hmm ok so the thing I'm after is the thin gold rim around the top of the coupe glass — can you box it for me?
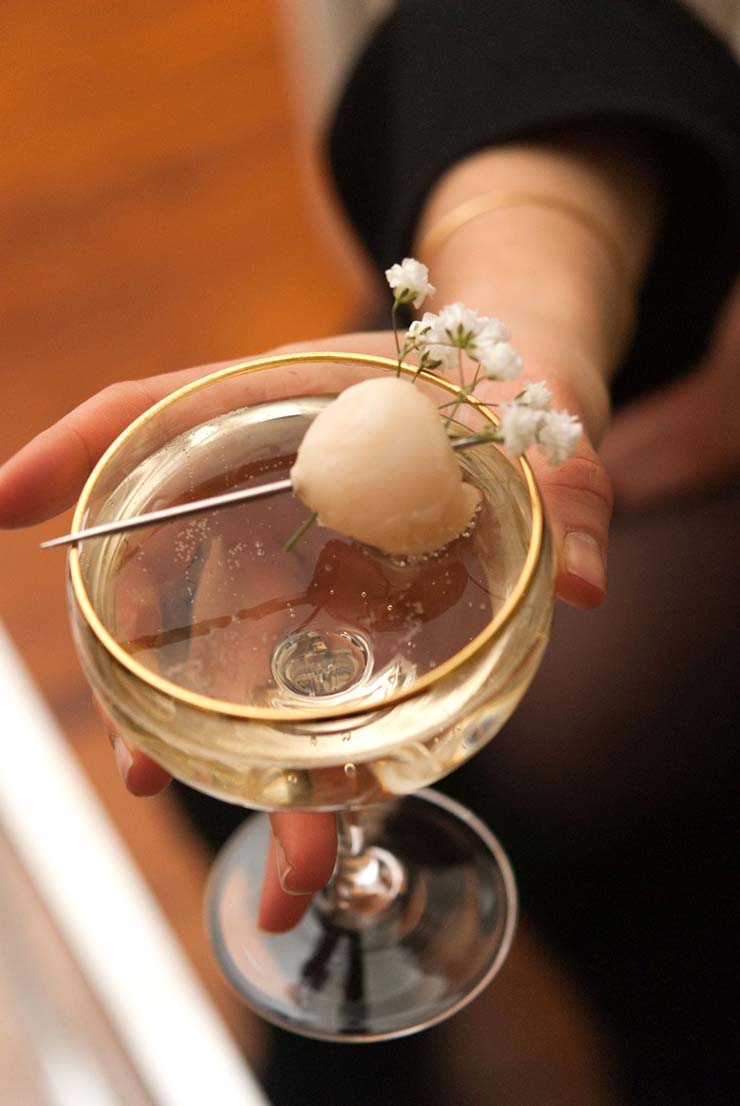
[69,352,544,722]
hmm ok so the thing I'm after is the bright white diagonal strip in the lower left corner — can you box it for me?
[0,625,268,1106]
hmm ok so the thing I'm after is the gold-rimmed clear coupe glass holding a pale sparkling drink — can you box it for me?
[69,353,553,1041]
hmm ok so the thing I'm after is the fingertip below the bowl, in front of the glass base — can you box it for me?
[258,813,336,933]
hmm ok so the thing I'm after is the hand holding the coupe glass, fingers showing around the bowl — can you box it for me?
[0,334,611,932]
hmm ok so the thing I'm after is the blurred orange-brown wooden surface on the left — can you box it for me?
[0,0,357,1057]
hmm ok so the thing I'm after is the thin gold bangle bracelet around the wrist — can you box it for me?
[417,192,633,288]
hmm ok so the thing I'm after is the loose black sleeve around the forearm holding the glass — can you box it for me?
[330,0,740,398]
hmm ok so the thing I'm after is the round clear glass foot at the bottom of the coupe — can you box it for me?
[207,791,517,1042]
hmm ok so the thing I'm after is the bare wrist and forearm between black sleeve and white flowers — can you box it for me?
[416,131,659,437]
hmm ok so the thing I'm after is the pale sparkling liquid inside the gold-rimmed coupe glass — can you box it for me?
[85,397,537,805]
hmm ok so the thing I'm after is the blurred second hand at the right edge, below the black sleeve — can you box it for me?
[602,280,740,510]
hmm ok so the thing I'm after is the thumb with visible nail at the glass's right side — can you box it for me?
[531,437,613,607]
